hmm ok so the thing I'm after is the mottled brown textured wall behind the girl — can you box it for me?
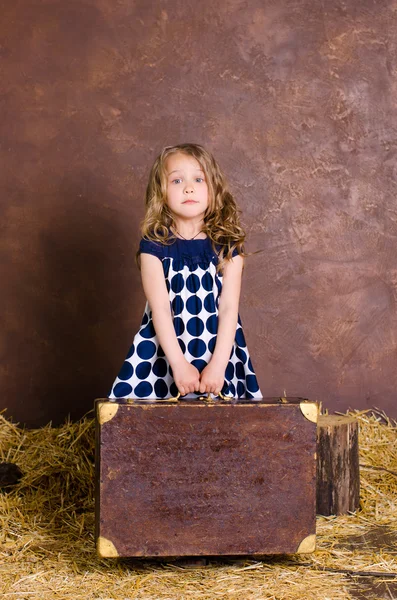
[0,0,397,426]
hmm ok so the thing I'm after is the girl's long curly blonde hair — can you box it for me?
[137,144,247,269]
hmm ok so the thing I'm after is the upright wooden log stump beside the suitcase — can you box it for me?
[317,415,360,515]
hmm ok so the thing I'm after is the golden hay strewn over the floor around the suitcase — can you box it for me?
[0,411,397,600]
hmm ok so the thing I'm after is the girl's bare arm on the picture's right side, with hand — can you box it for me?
[200,255,244,395]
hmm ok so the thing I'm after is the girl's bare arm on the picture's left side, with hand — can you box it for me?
[141,253,200,396]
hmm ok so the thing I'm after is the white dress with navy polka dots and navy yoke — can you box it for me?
[108,238,262,400]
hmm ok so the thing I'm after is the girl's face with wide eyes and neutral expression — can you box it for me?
[165,153,209,221]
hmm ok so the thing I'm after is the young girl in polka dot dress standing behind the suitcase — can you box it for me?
[109,144,262,400]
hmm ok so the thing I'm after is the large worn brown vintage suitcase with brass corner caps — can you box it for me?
[96,399,318,557]
